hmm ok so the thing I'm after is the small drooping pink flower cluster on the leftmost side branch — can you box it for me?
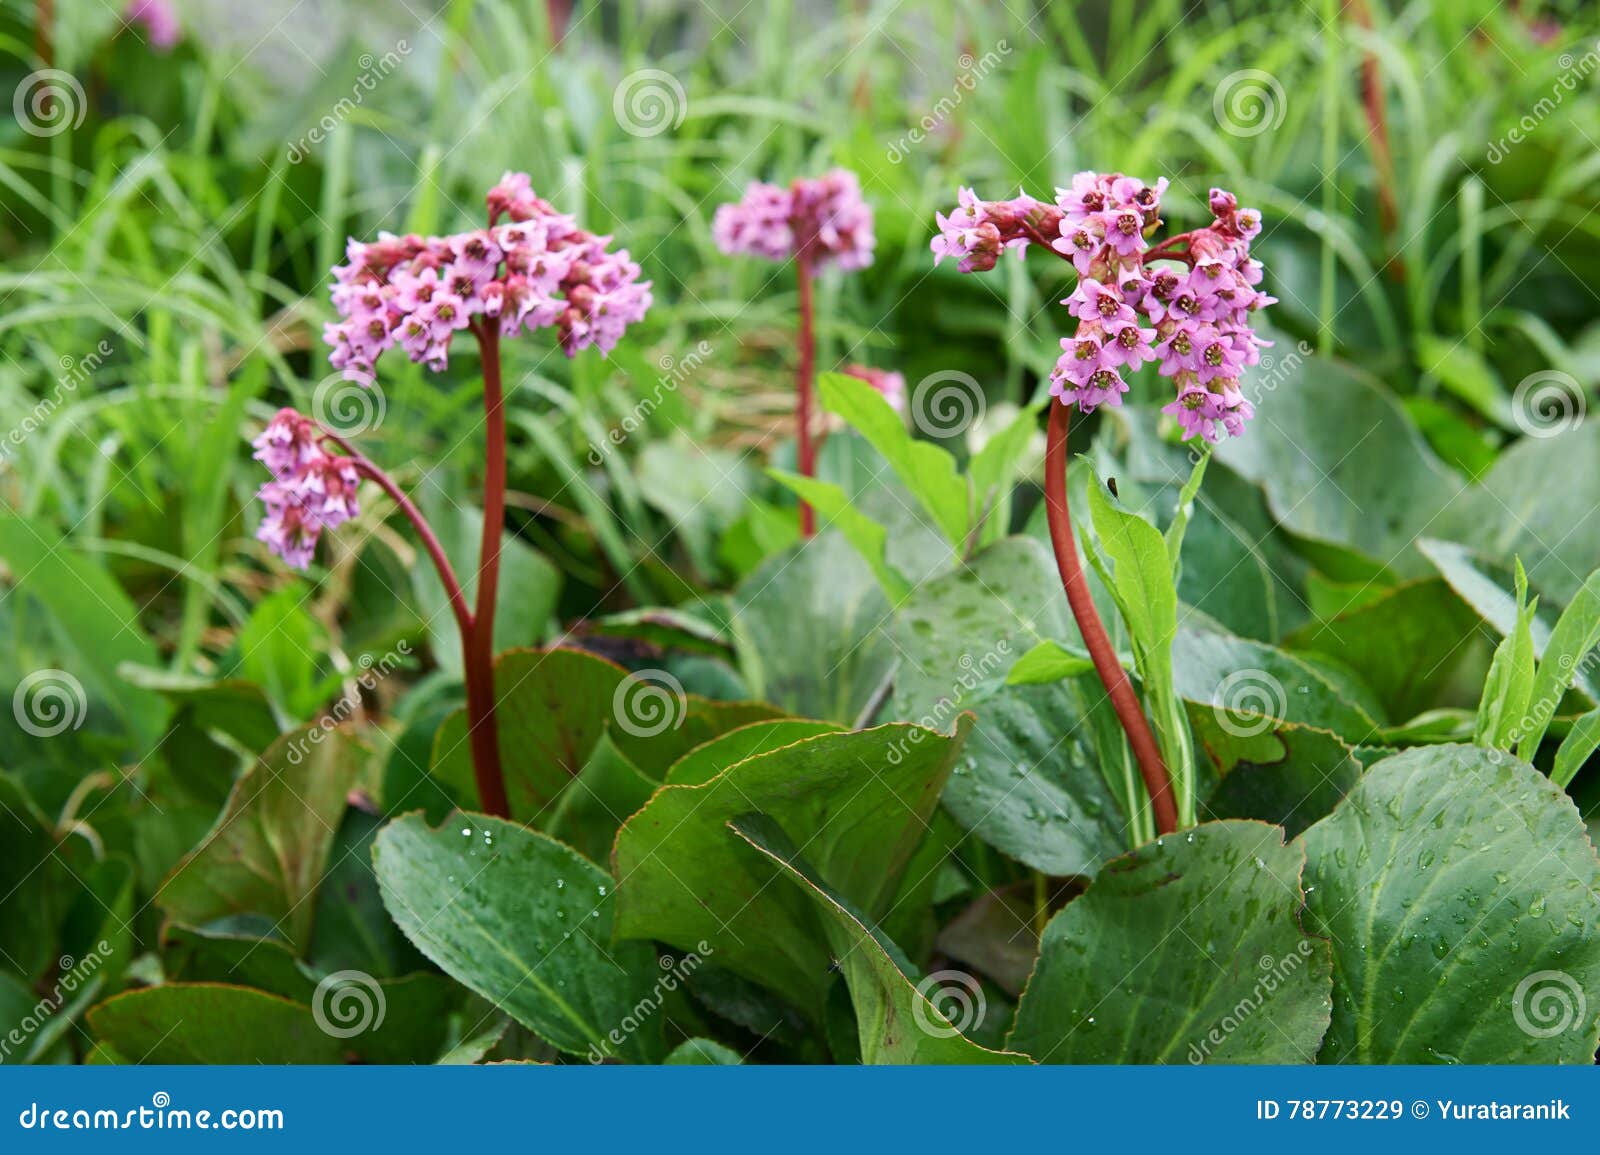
[253,410,362,570]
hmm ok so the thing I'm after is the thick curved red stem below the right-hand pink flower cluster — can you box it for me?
[1045,400,1178,833]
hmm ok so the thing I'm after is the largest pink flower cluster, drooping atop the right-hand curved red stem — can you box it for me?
[933,173,1274,442]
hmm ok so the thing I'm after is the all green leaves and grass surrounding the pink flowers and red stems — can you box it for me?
[0,0,1600,1064]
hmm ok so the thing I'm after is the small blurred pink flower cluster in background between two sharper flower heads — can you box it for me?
[710,168,877,269]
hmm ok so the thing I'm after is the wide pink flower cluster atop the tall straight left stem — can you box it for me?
[323,173,651,386]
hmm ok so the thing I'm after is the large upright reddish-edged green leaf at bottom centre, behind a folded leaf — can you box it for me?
[613,720,970,1021]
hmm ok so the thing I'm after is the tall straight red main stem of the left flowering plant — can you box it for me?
[462,323,510,817]
